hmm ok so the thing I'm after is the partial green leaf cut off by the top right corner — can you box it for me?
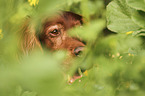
[126,0,145,11]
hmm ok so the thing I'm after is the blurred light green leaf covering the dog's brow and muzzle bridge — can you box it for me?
[69,20,105,41]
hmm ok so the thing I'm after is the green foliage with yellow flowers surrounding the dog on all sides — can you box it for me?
[0,0,145,96]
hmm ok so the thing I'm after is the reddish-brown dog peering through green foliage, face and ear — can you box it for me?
[22,12,85,56]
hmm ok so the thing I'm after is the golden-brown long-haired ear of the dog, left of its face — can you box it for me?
[20,17,42,54]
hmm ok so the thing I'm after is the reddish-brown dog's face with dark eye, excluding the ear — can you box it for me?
[39,12,85,56]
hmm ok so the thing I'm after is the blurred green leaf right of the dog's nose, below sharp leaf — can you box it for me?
[94,34,141,56]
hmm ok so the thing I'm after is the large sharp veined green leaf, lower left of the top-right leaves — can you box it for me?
[107,0,140,33]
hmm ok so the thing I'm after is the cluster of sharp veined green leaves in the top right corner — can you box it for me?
[107,0,145,35]
